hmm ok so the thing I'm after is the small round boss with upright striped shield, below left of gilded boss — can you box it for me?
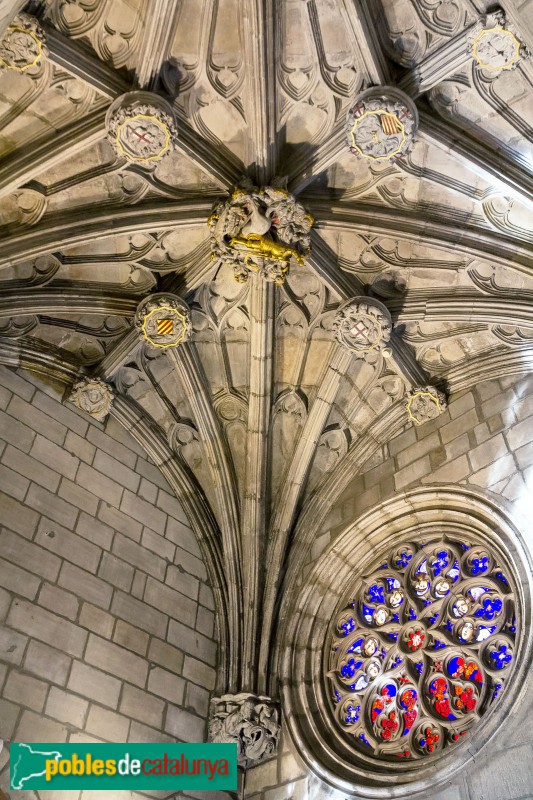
[135,292,192,347]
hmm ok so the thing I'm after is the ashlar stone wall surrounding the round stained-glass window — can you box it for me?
[245,377,533,800]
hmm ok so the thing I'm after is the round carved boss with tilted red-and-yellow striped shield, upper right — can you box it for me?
[347,86,418,161]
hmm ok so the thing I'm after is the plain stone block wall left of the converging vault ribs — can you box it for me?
[0,367,217,756]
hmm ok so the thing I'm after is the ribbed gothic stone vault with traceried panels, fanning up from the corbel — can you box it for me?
[0,0,533,716]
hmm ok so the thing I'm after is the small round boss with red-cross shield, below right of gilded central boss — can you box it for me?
[333,297,392,358]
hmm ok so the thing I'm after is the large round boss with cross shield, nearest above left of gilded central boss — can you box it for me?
[106,92,178,166]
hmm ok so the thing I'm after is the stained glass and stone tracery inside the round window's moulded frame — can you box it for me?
[327,536,517,761]
